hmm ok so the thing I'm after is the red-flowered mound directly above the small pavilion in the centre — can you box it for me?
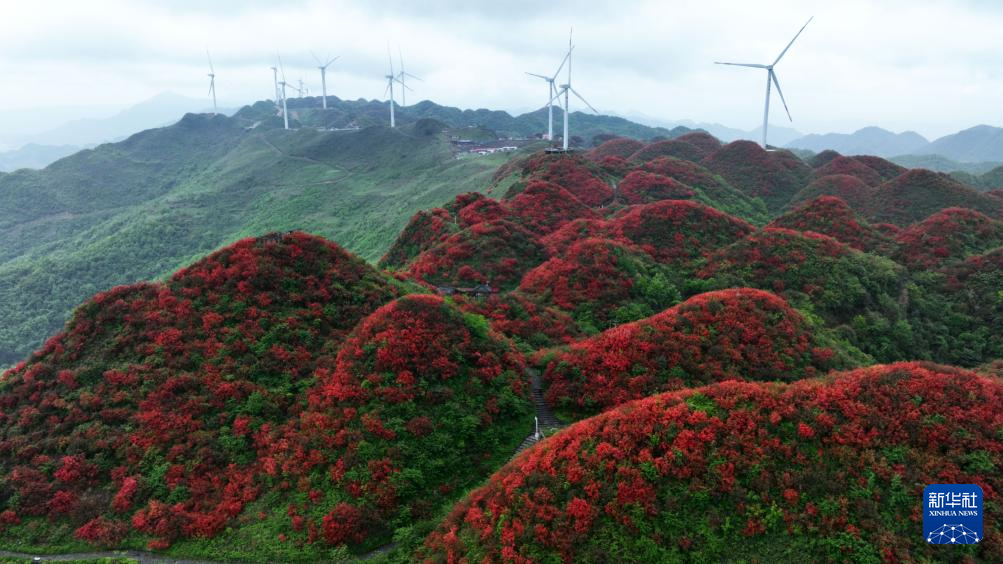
[407,220,545,289]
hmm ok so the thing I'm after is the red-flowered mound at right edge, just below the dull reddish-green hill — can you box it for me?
[896,208,1003,270]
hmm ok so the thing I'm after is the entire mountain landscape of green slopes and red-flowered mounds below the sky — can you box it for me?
[0,130,1003,563]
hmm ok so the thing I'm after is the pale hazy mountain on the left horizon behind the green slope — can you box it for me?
[28,91,227,146]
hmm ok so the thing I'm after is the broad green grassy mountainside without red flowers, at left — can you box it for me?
[0,116,521,366]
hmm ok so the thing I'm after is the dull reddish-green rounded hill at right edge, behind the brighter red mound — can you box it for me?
[862,169,1003,227]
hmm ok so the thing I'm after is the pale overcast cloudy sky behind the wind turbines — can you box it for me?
[0,0,1003,136]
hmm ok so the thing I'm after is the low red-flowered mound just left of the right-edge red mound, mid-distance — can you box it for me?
[767,196,893,252]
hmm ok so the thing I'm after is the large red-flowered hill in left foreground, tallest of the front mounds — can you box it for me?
[0,233,397,546]
